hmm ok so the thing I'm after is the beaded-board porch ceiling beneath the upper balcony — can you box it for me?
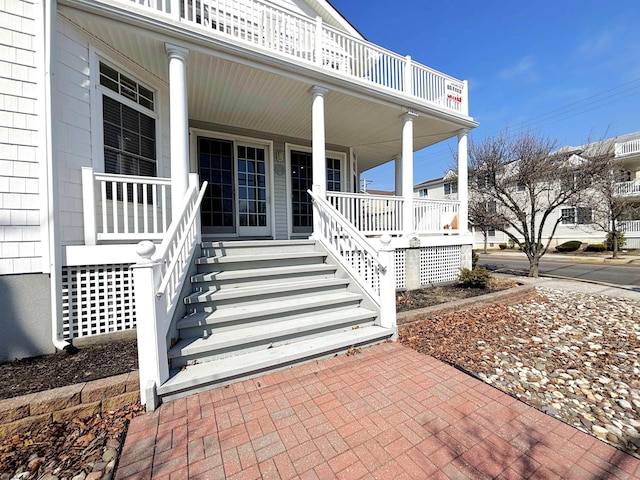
[59,6,464,170]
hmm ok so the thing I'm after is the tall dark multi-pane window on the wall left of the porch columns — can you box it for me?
[100,62,157,182]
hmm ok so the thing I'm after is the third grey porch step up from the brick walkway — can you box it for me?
[177,292,363,338]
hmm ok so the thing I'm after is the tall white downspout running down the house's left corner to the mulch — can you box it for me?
[41,0,71,350]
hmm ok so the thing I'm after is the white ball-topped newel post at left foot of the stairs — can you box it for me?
[131,240,169,411]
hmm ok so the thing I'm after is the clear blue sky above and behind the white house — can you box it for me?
[330,0,640,190]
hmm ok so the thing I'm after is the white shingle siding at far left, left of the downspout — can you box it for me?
[0,0,42,274]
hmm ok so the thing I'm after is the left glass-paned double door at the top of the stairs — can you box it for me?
[198,137,271,236]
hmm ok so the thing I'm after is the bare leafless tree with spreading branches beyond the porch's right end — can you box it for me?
[469,130,602,277]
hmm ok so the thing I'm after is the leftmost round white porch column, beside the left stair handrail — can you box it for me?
[165,43,189,218]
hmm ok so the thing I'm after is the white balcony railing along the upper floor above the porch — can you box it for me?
[120,0,469,115]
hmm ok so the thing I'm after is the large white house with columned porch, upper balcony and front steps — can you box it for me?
[0,0,477,403]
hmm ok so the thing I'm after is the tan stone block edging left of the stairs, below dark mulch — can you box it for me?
[0,371,140,440]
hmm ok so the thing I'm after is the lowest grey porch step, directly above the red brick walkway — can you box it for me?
[158,326,394,400]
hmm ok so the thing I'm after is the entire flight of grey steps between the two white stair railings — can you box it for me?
[158,240,388,400]
